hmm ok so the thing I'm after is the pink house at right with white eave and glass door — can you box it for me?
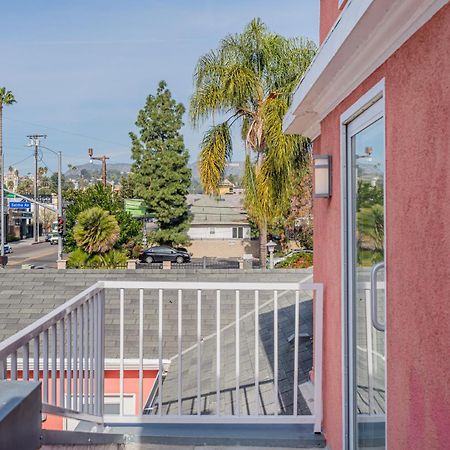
[284,0,450,450]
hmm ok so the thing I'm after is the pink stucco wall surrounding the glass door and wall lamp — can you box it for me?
[314,5,450,450]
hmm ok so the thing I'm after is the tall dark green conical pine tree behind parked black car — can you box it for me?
[130,81,191,245]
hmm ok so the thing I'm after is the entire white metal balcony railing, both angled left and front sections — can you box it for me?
[0,281,323,432]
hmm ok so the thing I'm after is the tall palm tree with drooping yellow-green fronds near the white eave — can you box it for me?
[190,19,316,267]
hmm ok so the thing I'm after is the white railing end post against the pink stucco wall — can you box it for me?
[313,284,323,433]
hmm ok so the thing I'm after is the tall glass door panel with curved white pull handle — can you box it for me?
[347,108,386,449]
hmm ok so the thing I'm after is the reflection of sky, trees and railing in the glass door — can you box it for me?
[351,119,386,449]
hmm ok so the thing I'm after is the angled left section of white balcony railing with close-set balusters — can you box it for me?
[0,283,104,422]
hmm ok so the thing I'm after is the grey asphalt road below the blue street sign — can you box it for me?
[7,238,58,269]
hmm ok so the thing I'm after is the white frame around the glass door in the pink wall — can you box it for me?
[340,78,387,450]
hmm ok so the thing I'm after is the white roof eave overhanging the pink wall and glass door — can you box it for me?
[283,0,448,139]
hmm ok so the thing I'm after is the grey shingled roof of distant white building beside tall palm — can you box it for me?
[187,194,248,225]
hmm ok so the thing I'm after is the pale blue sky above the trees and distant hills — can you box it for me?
[0,0,319,173]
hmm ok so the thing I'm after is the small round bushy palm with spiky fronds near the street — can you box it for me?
[73,206,120,254]
